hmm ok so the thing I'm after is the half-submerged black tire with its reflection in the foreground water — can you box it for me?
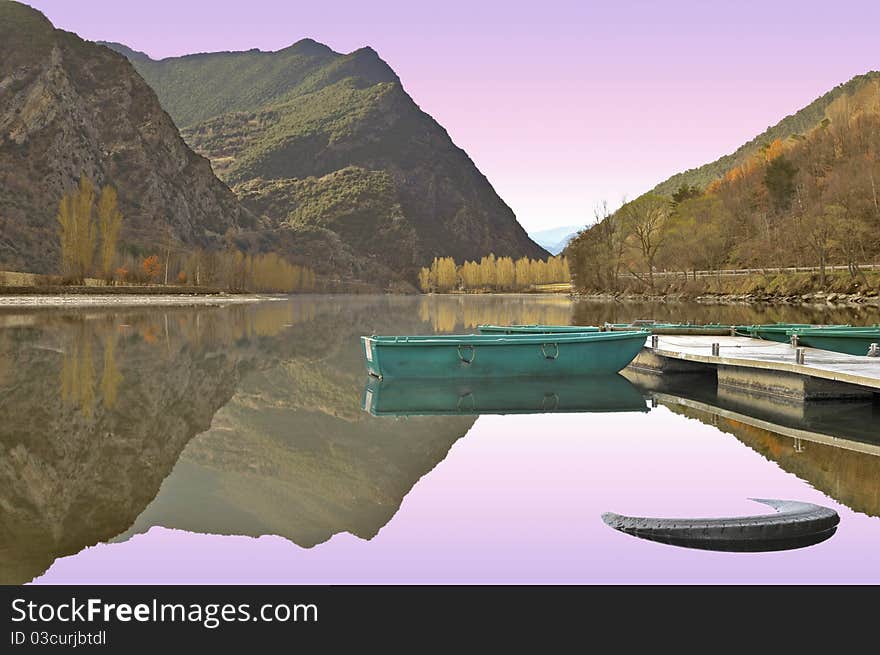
[602,498,840,552]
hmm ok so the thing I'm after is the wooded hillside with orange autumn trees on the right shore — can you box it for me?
[566,73,880,290]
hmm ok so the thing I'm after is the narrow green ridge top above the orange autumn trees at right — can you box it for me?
[651,71,880,196]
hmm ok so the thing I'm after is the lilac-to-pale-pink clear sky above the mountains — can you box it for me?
[29,0,880,231]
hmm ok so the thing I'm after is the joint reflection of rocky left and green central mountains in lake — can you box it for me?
[0,298,482,583]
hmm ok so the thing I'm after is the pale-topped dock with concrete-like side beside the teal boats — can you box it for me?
[630,335,880,402]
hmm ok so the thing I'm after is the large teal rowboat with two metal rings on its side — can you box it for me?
[361,331,648,378]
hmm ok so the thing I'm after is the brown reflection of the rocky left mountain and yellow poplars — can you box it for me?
[0,313,262,582]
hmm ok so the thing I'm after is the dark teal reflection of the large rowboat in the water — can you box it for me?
[363,374,648,416]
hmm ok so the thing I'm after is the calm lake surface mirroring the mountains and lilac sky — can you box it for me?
[0,296,880,584]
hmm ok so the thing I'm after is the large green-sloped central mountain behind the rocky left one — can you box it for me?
[107,39,547,280]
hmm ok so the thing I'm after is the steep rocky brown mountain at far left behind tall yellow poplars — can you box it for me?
[0,0,253,273]
